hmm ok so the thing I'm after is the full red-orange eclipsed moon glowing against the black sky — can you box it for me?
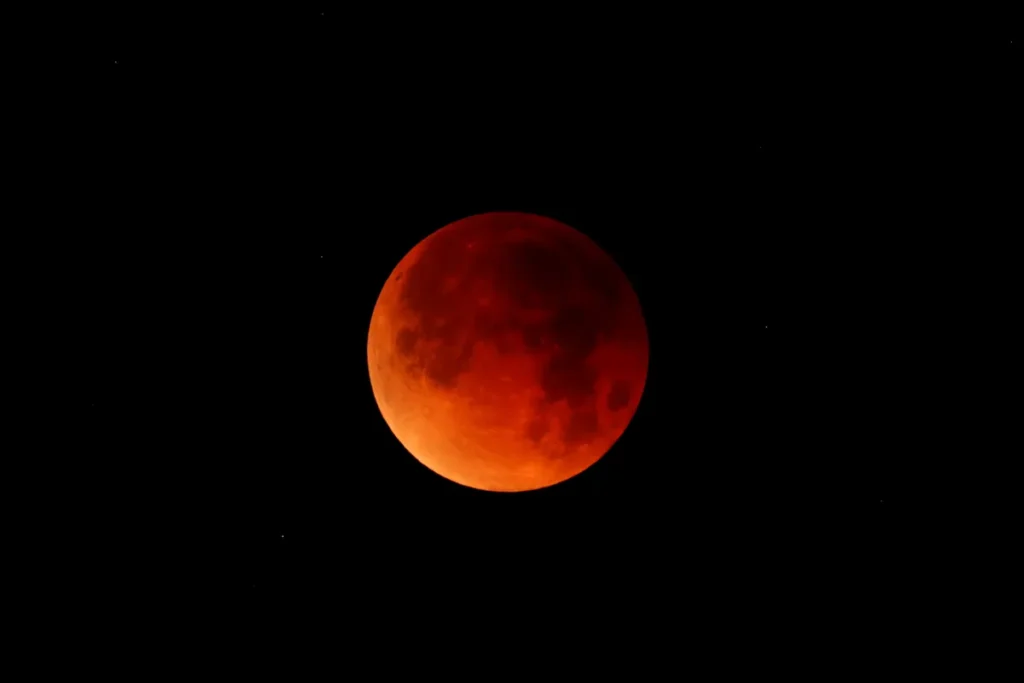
[367,213,648,492]
